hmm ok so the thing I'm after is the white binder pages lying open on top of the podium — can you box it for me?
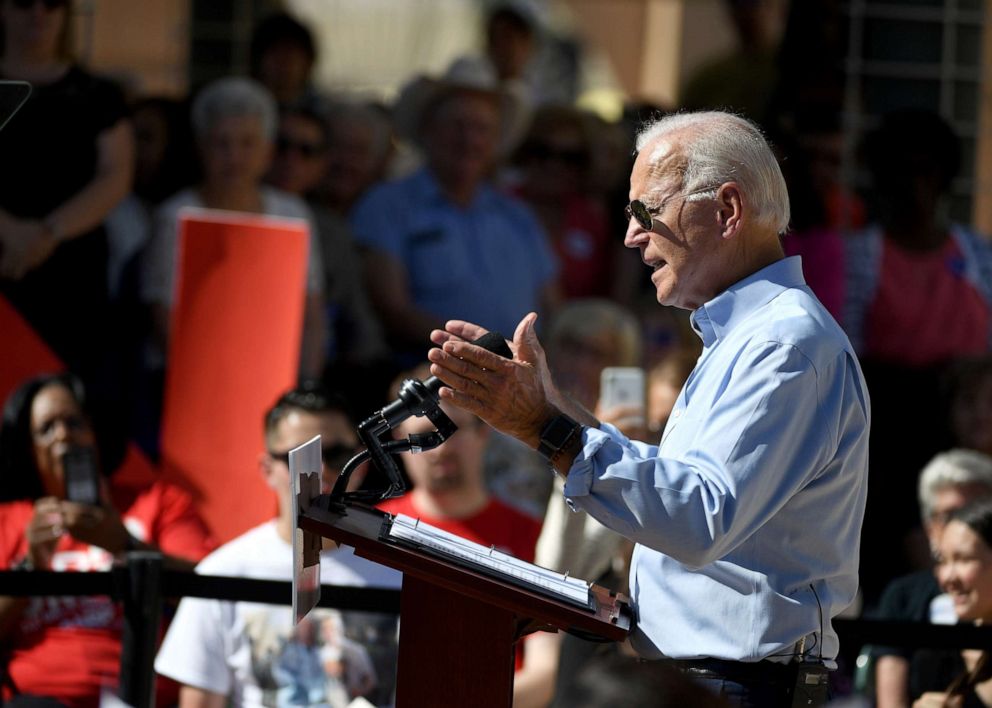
[385,514,595,610]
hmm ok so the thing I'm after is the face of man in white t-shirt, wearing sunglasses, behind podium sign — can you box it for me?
[262,409,363,502]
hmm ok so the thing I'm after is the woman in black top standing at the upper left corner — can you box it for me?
[0,0,133,388]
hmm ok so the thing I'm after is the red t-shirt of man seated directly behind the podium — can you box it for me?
[379,493,541,670]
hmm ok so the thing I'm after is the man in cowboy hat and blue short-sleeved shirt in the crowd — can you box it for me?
[351,58,559,361]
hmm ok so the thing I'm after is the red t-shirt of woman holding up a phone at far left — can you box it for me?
[0,481,216,708]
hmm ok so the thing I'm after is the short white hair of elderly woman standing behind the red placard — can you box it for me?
[191,76,279,141]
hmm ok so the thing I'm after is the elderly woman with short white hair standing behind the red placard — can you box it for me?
[141,78,325,378]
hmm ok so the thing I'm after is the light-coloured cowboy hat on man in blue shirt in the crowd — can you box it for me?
[393,57,530,155]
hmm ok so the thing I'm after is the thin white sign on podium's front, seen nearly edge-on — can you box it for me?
[289,435,323,622]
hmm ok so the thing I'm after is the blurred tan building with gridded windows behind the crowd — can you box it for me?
[76,0,992,233]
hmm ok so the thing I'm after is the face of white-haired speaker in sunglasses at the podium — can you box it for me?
[624,138,727,310]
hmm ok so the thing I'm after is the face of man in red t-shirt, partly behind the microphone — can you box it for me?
[397,405,489,497]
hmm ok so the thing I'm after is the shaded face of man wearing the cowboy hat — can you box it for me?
[424,91,499,191]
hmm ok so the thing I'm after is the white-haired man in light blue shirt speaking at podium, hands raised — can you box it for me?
[429,112,870,707]
